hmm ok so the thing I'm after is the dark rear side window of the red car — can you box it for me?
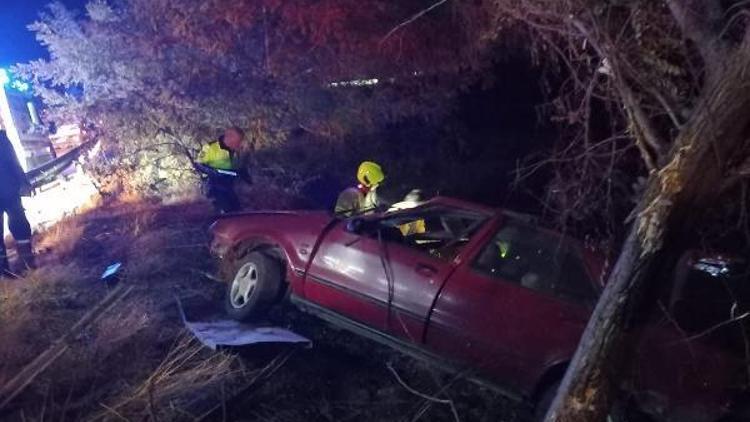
[473,222,596,303]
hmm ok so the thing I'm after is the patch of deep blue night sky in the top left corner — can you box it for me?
[0,0,87,67]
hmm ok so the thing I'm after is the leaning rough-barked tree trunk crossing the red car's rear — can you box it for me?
[546,50,750,422]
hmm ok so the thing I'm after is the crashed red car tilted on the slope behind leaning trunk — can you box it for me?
[211,198,745,421]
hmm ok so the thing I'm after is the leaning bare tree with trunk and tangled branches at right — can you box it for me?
[484,0,750,422]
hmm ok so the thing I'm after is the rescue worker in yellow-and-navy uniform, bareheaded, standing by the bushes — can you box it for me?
[196,127,252,213]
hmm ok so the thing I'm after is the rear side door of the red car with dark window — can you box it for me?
[426,220,596,392]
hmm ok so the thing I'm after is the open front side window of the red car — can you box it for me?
[379,207,486,259]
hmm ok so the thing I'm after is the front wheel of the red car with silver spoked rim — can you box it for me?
[224,252,283,321]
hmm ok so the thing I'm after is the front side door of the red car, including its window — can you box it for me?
[305,206,485,343]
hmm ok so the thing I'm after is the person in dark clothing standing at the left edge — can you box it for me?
[0,130,36,277]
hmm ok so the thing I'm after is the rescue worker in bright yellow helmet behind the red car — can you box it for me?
[335,161,385,217]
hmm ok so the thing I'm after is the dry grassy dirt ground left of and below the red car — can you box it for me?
[0,194,528,422]
